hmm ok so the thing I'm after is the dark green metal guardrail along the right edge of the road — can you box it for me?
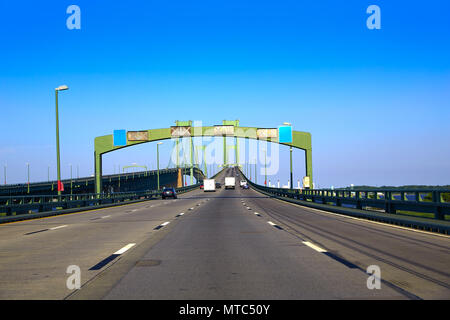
[241,172,450,234]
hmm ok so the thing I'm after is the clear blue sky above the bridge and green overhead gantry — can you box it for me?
[0,0,450,187]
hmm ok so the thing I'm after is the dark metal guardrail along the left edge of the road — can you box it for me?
[0,184,199,216]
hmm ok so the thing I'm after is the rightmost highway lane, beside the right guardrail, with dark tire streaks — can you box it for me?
[241,185,450,299]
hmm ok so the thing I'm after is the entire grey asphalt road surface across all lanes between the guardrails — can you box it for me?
[0,169,450,299]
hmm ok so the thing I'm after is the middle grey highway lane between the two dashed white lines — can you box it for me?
[86,169,411,299]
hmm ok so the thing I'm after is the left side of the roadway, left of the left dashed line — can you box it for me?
[0,186,210,299]
